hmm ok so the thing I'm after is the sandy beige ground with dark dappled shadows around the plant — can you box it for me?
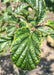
[0,0,54,75]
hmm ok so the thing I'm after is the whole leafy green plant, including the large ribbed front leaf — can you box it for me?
[0,0,54,70]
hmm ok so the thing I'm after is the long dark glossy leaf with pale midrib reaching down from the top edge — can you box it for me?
[26,0,46,23]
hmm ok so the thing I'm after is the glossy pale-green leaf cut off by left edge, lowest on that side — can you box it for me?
[0,35,11,53]
